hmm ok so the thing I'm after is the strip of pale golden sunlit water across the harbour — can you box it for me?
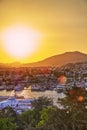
[0,87,64,103]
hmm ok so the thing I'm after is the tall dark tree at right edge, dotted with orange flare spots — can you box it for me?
[58,87,87,130]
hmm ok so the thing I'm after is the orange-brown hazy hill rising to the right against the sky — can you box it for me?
[24,51,87,67]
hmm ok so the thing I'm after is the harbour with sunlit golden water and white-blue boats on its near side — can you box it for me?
[0,87,65,112]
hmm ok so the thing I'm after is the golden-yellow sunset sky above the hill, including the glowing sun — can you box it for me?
[0,0,87,63]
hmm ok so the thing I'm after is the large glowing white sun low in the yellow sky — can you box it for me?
[2,26,40,60]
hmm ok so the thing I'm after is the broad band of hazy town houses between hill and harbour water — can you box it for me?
[0,62,87,91]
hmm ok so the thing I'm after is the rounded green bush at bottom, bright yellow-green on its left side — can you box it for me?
[37,107,70,130]
